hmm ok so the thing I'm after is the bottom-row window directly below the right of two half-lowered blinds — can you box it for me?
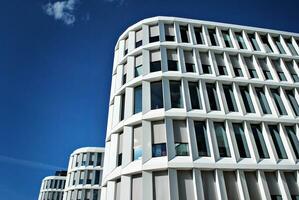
[177,170,196,200]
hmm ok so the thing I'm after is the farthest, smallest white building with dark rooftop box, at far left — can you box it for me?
[38,171,66,200]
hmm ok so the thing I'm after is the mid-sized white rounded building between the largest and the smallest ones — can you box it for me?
[63,147,104,200]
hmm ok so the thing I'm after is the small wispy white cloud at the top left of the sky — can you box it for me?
[43,0,79,25]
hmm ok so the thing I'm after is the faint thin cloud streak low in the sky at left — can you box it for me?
[0,155,63,170]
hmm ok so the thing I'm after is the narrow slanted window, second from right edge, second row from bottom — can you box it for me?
[269,125,288,159]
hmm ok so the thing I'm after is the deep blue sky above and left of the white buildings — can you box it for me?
[0,0,299,200]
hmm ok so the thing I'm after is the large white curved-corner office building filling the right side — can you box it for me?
[101,17,299,200]
